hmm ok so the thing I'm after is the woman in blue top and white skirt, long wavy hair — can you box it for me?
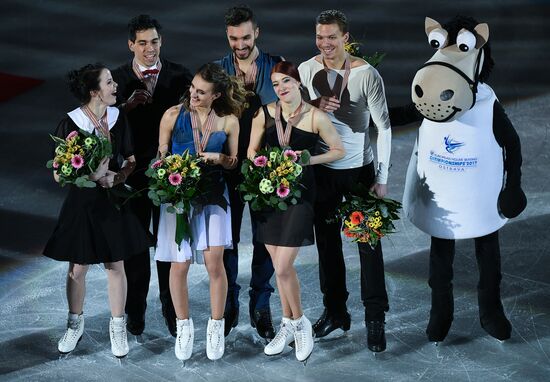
[155,64,246,360]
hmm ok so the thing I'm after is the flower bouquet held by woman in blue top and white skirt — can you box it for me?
[145,150,204,247]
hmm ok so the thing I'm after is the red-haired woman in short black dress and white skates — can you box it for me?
[247,61,344,361]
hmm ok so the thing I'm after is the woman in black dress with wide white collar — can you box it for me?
[44,64,152,357]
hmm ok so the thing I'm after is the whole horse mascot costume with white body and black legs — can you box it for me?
[403,16,527,343]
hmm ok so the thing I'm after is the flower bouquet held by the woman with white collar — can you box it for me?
[46,130,112,188]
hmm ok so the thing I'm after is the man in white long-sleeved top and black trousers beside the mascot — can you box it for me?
[298,10,391,352]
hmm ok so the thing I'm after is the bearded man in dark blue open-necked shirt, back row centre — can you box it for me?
[218,6,283,339]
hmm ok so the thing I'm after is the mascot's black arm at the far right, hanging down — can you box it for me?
[493,101,527,218]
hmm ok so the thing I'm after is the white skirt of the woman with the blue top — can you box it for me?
[155,188,233,264]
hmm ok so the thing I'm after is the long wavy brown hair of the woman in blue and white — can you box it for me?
[183,63,250,118]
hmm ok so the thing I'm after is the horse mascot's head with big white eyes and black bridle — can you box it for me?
[411,16,494,122]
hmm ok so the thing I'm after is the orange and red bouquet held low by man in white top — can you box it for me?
[336,188,401,248]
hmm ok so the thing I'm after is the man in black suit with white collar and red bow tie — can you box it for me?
[113,15,191,337]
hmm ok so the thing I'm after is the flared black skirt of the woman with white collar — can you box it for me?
[44,185,154,265]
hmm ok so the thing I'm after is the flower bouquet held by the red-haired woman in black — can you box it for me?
[239,147,310,211]
